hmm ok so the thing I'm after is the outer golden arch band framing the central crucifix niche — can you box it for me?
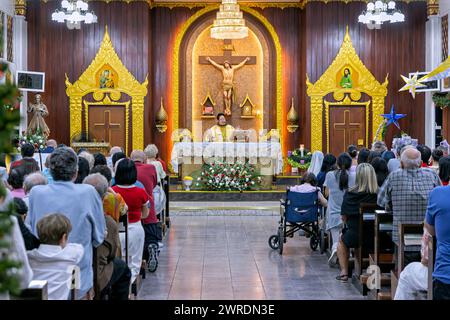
[172,5,283,150]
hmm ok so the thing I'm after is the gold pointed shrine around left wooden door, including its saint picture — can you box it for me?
[66,27,148,152]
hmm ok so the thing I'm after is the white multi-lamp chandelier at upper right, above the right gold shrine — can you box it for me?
[358,0,405,29]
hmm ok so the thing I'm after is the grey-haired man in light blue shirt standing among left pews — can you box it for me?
[26,147,106,298]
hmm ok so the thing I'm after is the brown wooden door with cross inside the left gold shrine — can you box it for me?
[89,105,126,150]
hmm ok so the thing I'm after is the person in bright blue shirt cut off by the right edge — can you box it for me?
[425,182,450,300]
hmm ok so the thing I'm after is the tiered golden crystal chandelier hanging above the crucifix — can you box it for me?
[211,0,248,39]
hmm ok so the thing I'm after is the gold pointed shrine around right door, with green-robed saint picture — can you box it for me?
[306,27,388,152]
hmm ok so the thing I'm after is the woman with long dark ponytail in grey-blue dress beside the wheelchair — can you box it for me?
[323,152,355,266]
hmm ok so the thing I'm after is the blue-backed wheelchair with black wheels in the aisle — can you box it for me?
[269,189,322,254]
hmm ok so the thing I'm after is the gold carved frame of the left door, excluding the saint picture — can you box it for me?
[65,27,148,149]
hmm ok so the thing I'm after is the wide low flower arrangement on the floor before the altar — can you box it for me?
[195,162,261,192]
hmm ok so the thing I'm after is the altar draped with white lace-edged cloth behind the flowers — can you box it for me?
[171,142,283,190]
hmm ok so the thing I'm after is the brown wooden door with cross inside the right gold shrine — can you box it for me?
[329,106,367,157]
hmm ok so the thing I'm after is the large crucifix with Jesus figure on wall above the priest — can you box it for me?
[199,39,256,116]
